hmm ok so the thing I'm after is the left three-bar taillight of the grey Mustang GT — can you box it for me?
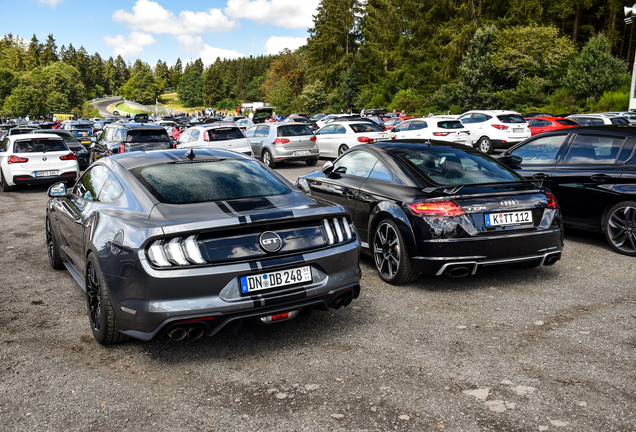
[148,235,206,267]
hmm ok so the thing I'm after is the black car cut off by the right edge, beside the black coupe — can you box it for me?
[499,125,636,256]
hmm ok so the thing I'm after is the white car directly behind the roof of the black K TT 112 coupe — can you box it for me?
[391,116,473,146]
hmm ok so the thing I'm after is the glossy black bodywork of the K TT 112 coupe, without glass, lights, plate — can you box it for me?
[299,141,563,274]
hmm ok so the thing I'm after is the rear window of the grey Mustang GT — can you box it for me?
[138,160,290,204]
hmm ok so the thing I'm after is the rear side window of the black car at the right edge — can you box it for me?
[565,134,625,164]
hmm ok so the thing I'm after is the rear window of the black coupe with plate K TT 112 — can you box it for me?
[399,147,523,186]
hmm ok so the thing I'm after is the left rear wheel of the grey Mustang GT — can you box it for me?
[86,254,130,345]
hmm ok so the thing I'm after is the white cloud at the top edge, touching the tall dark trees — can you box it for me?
[225,0,320,29]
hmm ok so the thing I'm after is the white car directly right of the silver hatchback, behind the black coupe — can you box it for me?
[316,120,391,158]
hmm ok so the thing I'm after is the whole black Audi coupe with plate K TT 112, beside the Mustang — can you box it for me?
[297,141,563,284]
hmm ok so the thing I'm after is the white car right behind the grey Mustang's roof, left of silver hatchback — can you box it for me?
[177,123,254,156]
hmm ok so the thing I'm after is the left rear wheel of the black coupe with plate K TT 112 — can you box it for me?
[371,219,420,285]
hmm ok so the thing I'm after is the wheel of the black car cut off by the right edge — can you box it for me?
[603,201,636,256]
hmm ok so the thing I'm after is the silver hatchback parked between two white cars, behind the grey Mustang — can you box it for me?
[245,123,320,168]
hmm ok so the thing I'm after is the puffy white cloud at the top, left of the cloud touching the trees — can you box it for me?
[113,0,237,35]
